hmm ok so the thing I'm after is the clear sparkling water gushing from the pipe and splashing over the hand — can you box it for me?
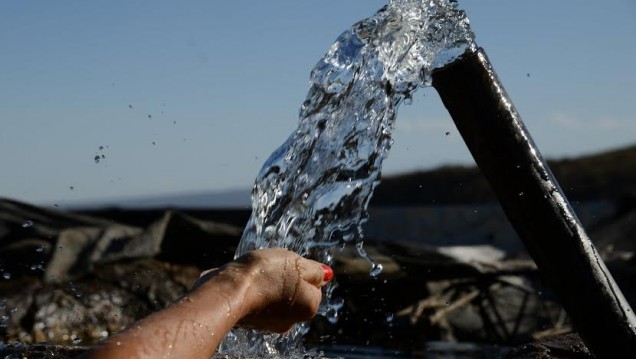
[220,0,474,358]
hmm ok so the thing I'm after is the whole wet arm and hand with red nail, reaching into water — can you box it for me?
[80,248,331,359]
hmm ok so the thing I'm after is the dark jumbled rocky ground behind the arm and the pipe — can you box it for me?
[0,195,636,358]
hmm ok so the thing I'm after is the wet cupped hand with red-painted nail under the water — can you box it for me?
[194,248,333,333]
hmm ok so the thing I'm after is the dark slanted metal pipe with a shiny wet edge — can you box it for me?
[433,49,636,358]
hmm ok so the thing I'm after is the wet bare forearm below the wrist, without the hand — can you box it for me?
[85,276,250,359]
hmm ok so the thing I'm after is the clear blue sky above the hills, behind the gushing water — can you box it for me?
[0,0,636,203]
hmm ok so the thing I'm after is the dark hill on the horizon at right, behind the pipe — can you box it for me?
[371,146,636,205]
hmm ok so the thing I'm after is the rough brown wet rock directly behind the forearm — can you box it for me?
[0,259,200,345]
